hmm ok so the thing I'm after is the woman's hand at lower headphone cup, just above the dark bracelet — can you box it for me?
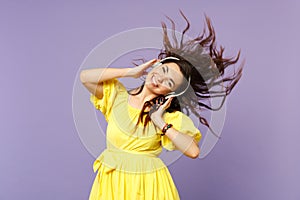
[149,97,173,129]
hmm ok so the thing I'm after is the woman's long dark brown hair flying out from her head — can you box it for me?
[129,11,244,138]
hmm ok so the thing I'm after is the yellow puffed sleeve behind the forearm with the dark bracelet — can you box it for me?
[161,111,202,151]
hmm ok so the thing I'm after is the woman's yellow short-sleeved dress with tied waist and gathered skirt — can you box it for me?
[89,78,201,200]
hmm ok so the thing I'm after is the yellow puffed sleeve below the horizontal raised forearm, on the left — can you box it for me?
[90,78,120,121]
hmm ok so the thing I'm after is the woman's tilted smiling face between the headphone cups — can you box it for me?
[145,62,183,95]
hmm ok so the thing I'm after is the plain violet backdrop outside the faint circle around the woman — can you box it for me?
[0,0,300,200]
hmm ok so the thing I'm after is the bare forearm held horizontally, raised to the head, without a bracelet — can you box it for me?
[80,68,130,84]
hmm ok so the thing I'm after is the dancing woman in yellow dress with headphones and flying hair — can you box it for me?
[80,12,242,200]
